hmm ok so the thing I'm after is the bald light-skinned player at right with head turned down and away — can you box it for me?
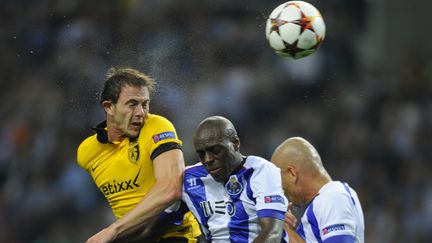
[271,137,364,243]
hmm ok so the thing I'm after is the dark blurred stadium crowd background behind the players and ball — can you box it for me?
[0,0,432,243]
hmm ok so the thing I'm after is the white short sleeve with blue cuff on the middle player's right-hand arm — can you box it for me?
[250,162,288,220]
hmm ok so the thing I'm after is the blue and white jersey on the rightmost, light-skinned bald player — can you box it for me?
[297,181,364,243]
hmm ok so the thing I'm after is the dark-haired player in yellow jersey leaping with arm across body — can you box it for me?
[77,68,200,242]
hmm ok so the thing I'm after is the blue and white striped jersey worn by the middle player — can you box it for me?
[183,156,288,243]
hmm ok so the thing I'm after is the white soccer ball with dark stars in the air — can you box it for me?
[266,1,325,59]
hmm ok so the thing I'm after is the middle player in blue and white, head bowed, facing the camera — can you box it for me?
[182,116,288,243]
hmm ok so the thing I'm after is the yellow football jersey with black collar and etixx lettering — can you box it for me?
[77,114,201,239]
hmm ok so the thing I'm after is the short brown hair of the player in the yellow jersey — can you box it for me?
[100,68,156,103]
